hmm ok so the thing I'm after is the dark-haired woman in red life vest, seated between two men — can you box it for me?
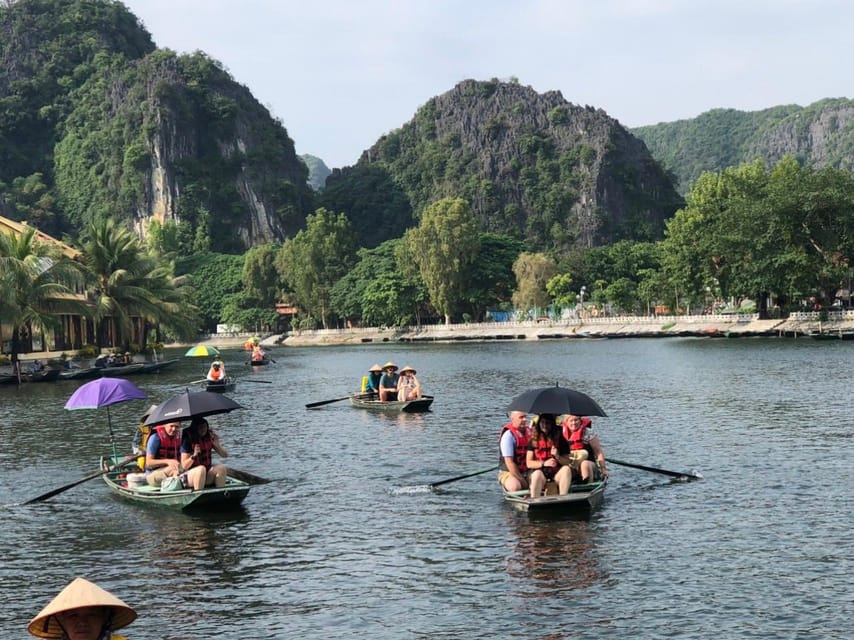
[525,413,572,498]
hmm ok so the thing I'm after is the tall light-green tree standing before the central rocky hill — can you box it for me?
[401,198,480,324]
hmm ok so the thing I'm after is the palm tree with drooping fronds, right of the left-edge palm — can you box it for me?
[83,220,196,348]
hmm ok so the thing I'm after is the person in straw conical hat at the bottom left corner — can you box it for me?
[27,578,136,640]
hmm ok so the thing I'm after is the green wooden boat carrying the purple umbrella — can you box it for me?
[102,461,252,510]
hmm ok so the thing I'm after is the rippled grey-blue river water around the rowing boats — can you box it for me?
[0,339,854,640]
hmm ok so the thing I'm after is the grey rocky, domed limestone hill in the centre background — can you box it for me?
[359,80,681,247]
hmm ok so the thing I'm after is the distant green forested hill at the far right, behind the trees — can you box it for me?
[632,98,854,193]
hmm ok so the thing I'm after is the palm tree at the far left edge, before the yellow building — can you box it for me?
[0,227,88,380]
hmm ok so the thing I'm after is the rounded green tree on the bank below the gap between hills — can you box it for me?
[276,208,356,328]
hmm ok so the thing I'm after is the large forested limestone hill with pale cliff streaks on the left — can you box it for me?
[0,0,314,252]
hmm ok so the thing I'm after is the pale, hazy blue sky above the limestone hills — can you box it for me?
[122,0,854,168]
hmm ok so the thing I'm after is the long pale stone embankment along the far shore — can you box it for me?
[280,311,854,347]
